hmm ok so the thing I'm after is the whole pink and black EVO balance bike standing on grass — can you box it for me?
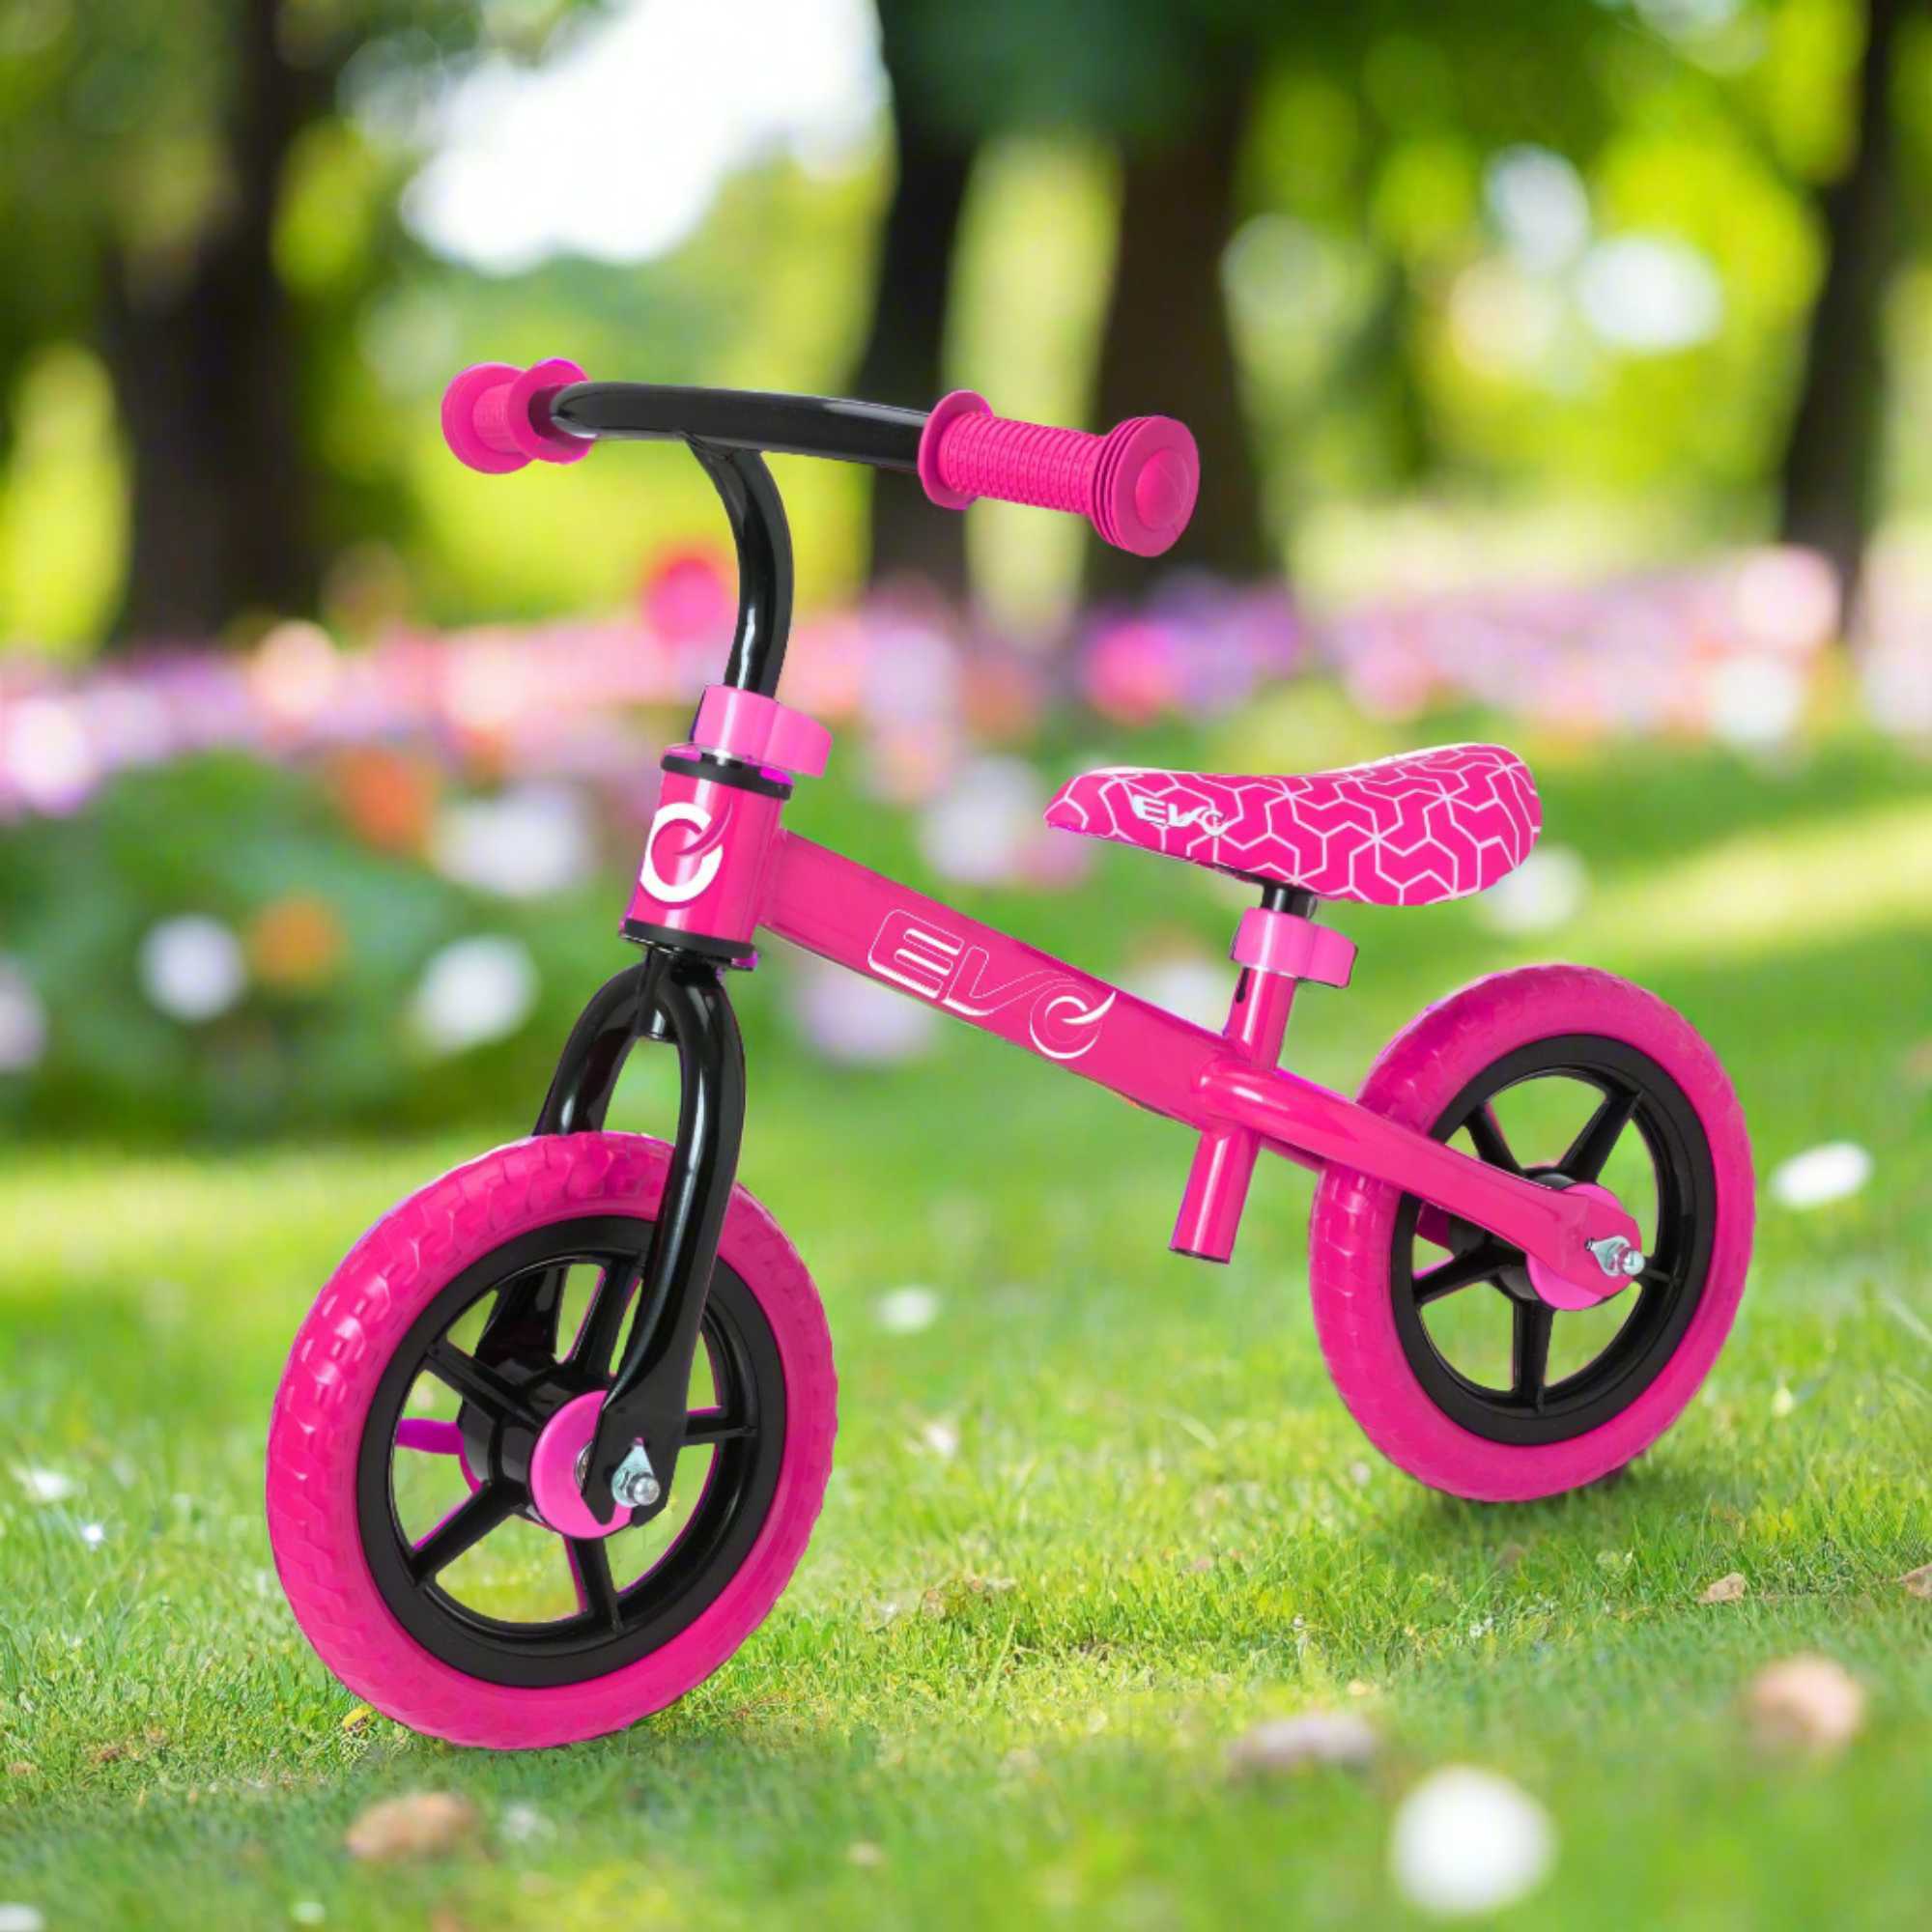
[269,361,1752,1747]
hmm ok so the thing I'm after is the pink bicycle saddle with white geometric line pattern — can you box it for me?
[1047,744,1544,906]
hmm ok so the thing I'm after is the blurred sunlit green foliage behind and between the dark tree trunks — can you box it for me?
[0,0,1932,649]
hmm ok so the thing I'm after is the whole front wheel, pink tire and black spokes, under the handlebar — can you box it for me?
[269,1134,837,1748]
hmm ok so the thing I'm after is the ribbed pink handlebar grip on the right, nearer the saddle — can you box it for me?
[920,388,1202,556]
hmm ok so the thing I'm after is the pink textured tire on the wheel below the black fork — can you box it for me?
[267,1134,837,1750]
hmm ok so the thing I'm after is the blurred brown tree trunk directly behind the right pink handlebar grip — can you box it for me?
[1088,79,1279,595]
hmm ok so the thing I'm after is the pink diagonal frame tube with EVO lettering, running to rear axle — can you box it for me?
[759,831,1640,1296]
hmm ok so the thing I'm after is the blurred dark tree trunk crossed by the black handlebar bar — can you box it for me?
[854,6,972,597]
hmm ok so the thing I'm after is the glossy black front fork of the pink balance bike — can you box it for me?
[535,947,744,1522]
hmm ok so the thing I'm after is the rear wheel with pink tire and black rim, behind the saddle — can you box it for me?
[1310,966,1754,1501]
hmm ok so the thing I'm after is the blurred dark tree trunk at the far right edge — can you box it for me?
[1779,0,1920,616]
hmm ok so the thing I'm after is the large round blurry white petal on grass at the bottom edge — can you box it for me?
[1389,1764,1555,1918]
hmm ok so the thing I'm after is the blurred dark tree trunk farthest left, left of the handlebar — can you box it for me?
[102,0,321,641]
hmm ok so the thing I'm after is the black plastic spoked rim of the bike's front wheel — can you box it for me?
[355,1215,786,1687]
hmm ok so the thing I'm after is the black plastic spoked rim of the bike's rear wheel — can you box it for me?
[1391,1034,1718,1445]
